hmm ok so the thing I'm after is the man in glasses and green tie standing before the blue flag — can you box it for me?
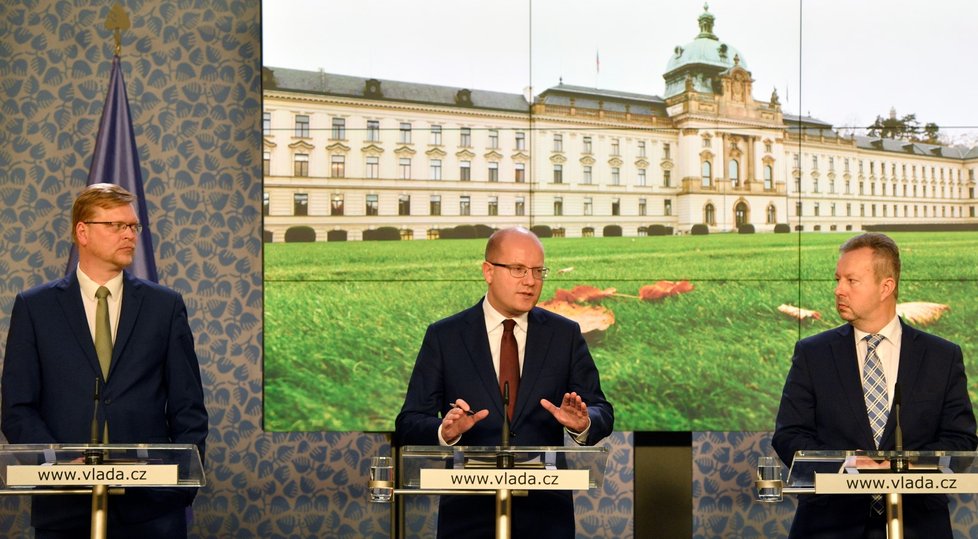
[0,184,207,539]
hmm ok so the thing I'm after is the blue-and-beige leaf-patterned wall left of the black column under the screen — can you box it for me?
[0,0,632,538]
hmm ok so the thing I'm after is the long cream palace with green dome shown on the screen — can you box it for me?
[263,6,978,242]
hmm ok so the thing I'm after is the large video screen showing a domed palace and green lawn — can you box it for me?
[262,0,978,431]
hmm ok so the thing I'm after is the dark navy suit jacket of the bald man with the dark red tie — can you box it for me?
[394,300,614,537]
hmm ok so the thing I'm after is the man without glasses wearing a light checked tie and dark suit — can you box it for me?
[772,233,978,539]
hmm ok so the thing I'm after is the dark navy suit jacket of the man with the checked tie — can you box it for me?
[772,320,978,539]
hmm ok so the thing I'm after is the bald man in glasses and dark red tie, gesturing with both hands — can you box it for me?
[395,227,614,538]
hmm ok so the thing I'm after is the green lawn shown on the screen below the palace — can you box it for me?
[264,232,978,431]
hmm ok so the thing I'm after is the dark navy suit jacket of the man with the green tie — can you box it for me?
[0,272,207,533]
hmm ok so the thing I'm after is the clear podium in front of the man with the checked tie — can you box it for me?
[754,450,978,539]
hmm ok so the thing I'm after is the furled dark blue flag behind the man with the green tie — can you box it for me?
[65,56,159,282]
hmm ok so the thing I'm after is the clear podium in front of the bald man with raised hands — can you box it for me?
[370,446,608,539]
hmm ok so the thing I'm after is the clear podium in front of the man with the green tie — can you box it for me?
[0,444,206,539]
